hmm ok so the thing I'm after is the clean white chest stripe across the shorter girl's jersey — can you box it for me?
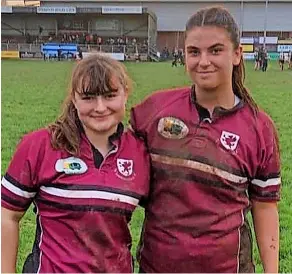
[40,186,139,206]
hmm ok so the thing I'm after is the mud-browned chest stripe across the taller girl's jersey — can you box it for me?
[150,154,247,184]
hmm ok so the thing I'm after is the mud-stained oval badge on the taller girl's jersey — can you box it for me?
[157,117,189,139]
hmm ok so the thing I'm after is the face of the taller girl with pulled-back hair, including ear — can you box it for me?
[185,26,242,91]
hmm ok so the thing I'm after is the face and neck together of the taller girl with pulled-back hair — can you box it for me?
[185,26,242,113]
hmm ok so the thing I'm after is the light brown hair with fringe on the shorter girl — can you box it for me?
[48,53,132,156]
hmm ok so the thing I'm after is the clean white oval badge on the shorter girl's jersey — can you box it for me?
[55,157,88,174]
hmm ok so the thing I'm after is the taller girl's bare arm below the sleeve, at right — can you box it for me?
[252,200,279,273]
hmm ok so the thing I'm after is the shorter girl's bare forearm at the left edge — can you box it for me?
[1,219,19,273]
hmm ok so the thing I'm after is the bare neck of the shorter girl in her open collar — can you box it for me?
[84,126,117,156]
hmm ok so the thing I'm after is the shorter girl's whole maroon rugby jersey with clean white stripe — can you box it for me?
[2,125,149,273]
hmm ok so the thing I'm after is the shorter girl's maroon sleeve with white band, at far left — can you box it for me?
[1,135,38,211]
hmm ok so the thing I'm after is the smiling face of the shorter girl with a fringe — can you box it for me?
[73,78,128,135]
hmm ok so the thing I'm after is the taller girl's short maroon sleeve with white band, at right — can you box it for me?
[249,118,281,202]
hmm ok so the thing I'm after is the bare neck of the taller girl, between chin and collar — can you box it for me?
[195,83,235,113]
